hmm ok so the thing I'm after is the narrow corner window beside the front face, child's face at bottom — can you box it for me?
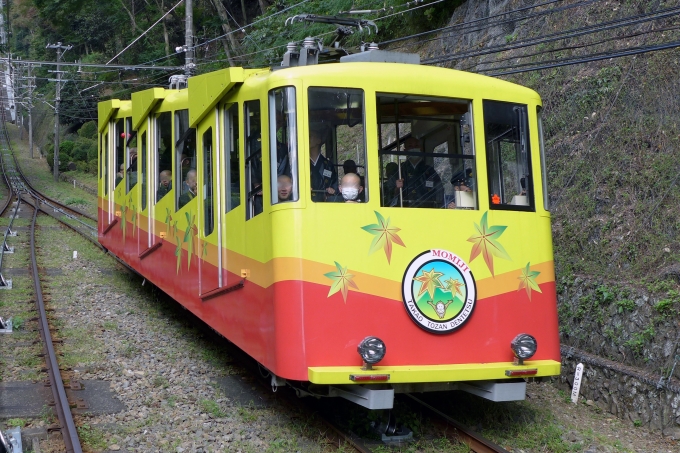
[269,87,298,204]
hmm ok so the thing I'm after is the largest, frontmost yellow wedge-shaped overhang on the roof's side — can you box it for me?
[189,67,245,127]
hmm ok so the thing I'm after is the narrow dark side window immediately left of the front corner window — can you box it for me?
[244,101,262,220]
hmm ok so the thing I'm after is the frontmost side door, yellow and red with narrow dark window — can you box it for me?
[198,109,222,300]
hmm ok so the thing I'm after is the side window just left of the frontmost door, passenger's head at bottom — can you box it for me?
[174,109,196,209]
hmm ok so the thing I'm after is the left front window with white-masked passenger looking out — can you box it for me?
[307,87,368,202]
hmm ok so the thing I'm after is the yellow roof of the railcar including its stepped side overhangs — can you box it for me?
[99,58,541,130]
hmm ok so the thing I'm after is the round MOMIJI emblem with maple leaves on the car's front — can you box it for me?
[401,249,477,333]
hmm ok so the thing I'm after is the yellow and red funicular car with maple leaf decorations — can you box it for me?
[99,50,560,409]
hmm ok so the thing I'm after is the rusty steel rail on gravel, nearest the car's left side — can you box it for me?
[31,199,83,453]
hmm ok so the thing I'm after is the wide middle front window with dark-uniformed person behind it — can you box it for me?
[377,94,477,209]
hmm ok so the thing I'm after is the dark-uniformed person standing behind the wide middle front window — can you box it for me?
[395,137,443,208]
